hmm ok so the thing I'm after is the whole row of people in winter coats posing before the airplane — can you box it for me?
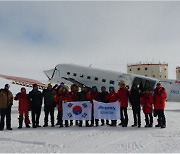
[0,80,167,130]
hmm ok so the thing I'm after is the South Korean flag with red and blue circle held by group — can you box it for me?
[63,101,92,120]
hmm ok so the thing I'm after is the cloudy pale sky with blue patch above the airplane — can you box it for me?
[0,1,180,79]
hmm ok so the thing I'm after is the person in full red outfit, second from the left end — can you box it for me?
[14,87,30,129]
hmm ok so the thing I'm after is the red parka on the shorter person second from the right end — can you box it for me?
[140,93,154,114]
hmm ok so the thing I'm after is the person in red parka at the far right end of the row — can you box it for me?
[154,83,167,128]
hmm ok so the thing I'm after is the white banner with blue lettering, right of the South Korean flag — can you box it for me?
[93,100,120,120]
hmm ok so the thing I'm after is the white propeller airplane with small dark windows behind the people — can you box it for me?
[0,64,180,102]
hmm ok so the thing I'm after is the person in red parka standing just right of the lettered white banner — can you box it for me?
[117,80,129,127]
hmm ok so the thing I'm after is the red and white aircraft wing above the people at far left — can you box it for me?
[0,74,46,89]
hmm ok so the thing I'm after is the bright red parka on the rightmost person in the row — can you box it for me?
[154,87,167,110]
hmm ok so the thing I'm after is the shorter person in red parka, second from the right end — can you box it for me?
[140,88,154,127]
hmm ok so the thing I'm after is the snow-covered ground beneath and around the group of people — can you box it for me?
[0,79,180,153]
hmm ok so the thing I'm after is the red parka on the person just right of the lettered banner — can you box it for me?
[117,88,129,107]
